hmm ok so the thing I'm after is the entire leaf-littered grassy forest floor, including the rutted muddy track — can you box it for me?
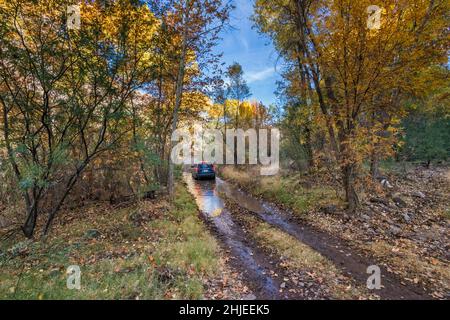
[0,165,450,299]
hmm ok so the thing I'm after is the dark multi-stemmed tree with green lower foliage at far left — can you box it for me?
[0,0,157,237]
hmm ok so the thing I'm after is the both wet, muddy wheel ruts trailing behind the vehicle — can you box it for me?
[184,173,429,299]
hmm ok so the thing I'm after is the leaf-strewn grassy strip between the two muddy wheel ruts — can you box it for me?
[227,202,372,300]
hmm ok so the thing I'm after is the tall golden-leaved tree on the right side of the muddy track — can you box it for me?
[255,0,449,211]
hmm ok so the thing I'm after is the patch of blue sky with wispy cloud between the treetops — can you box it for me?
[217,0,281,105]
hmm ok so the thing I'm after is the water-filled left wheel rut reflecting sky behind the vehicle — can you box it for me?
[183,173,283,299]
